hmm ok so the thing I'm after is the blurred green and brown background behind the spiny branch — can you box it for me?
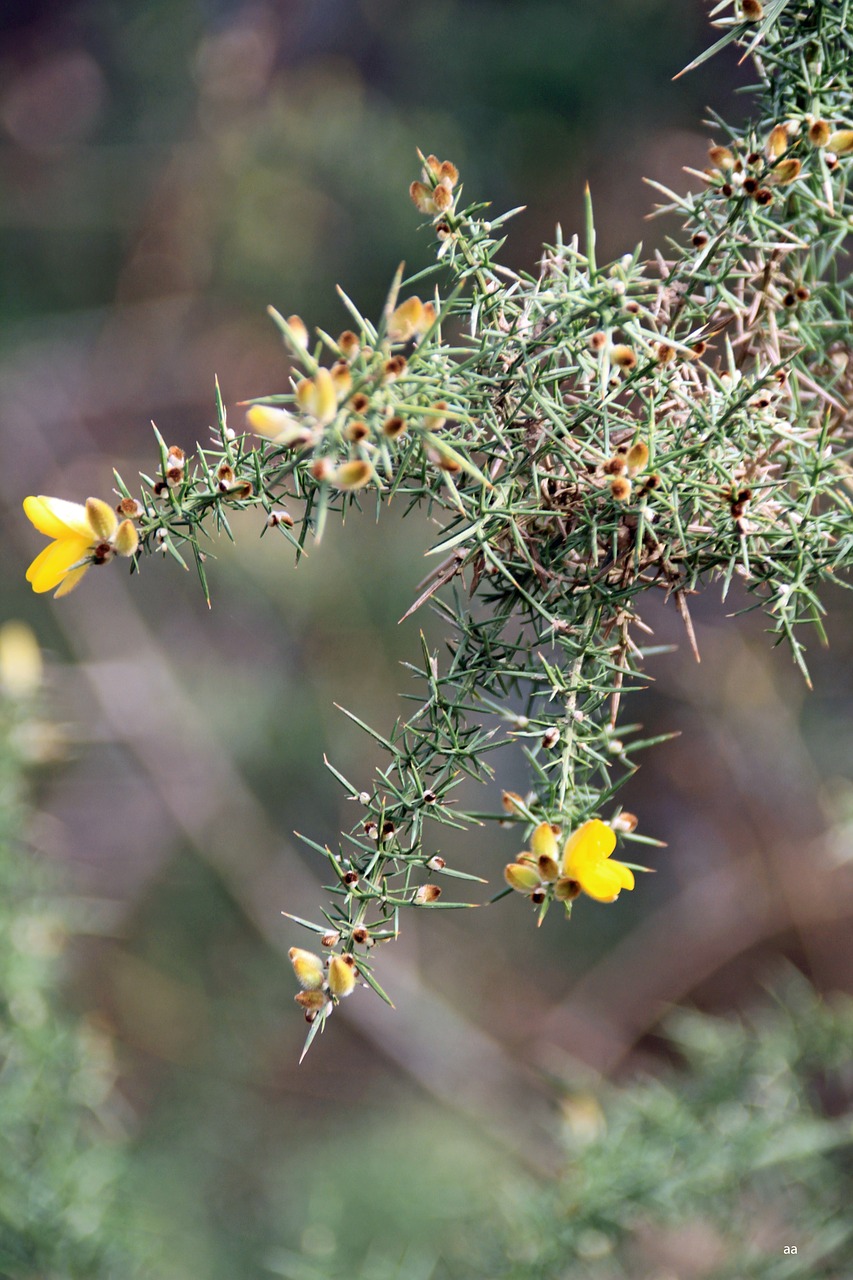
[0,0,853,1280]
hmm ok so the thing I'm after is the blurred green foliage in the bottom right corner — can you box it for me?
[508,977,853,1280]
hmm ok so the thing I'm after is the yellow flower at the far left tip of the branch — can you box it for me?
[23,497,130,596]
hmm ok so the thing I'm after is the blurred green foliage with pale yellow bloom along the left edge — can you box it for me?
[0,623,129,1280]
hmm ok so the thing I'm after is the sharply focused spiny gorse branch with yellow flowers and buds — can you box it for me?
[27,0,853,1059]
